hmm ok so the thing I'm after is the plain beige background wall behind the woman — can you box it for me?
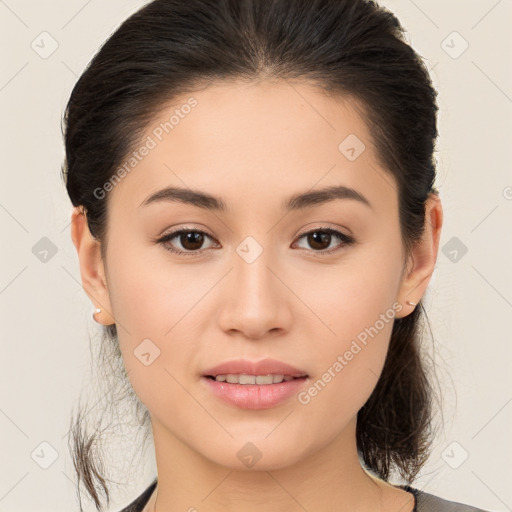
[0,0,512,512]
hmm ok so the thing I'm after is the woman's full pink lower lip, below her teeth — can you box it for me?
[201,377,308,409]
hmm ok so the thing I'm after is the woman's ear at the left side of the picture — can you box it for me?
[71,206,115,325]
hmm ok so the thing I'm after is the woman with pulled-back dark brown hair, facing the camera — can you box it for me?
[63,0,490,512]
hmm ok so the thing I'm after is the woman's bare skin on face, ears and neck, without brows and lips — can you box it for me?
[72,82,442,512]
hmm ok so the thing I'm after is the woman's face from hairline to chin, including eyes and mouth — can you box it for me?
[75,82,435,469]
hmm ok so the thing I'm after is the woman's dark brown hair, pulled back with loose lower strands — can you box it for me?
[62,0,438,510]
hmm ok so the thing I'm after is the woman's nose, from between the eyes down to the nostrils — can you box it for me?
[216,237,289,338]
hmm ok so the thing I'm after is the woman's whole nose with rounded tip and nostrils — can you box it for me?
[219,250,292,340]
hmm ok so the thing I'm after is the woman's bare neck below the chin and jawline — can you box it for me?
[147,419,412,512]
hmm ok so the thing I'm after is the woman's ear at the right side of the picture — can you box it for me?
[396,193,443,318]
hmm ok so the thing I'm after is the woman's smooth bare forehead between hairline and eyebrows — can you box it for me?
[107,80,394,214]
